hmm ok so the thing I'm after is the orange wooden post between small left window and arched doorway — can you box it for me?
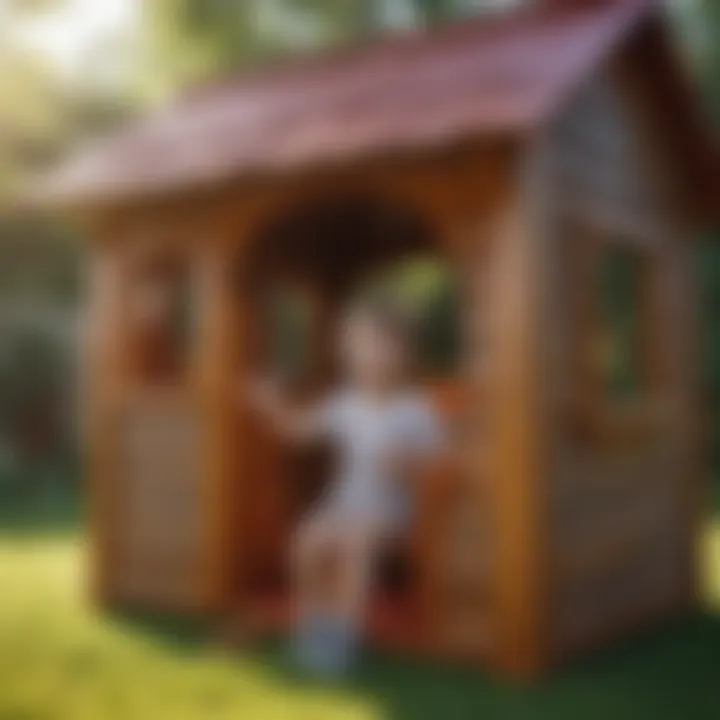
[195,212,250,610]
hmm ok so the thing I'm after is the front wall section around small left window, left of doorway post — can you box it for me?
[85,213,222,611]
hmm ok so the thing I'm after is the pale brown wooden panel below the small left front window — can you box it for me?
[112,392,206,608]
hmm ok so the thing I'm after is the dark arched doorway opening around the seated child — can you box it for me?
[233,197,461,632]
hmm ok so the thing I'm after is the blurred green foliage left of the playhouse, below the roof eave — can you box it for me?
[0,218,80,504]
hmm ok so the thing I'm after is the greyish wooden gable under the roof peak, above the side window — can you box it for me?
[548,63,676,246]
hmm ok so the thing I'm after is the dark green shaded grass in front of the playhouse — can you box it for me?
[116,614,720,720]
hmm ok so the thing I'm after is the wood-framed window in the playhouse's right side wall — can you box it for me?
[557,221,667,447]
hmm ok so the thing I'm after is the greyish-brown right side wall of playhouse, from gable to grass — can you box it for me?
[544,62,698,659]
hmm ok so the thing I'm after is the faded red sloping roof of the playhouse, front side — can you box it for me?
[39,0,716,211]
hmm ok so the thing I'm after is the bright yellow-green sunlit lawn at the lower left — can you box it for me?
[0,538,384,720]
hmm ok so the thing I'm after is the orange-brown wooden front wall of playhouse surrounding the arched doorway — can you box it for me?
[83,145,513,636]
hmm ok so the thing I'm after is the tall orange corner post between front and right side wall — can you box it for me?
[476,143,551,677]
